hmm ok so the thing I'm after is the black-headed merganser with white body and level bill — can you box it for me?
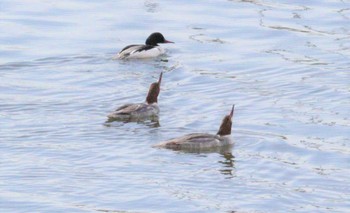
[117,32,174,59]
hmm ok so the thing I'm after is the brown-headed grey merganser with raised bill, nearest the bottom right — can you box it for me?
[153,105,235,150]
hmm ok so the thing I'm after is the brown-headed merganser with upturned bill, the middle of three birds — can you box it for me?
[108,72,163,121]
